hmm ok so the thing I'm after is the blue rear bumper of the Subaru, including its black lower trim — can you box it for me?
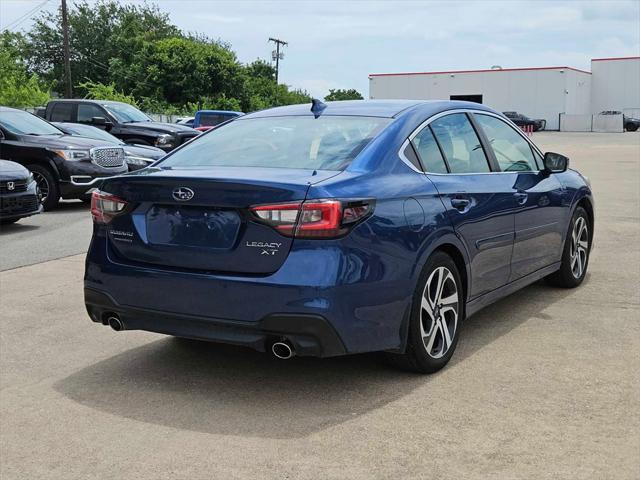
[84,232,415,356]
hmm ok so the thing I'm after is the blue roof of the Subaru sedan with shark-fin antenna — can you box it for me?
[238,100,493,120]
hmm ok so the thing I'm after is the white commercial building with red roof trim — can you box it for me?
[369,57,640,130]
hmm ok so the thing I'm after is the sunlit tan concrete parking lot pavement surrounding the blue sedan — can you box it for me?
[0,133,640,480]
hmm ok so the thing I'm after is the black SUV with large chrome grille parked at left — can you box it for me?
[0,107,128,210]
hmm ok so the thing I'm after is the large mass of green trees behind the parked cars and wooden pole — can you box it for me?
[16,0,318,114]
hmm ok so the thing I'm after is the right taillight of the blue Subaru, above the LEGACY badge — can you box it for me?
[251,200,374,238]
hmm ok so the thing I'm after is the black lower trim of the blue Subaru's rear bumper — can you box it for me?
[84,288,346,357]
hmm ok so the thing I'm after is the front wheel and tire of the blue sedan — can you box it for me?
[545,207,593,288]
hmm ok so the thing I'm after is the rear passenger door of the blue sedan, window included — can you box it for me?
[412,113,515,298]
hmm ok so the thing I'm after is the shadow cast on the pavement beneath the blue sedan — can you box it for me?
[55,283,571,438]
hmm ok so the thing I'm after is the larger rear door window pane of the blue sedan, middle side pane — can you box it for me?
[431,113,491,173]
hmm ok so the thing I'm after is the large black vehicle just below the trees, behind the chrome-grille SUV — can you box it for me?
[44,99,198,152]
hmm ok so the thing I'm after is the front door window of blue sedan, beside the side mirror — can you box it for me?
[474,114,537,172]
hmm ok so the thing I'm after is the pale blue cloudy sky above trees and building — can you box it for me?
[0,0,640,97]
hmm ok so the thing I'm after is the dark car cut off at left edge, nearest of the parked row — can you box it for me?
[0,160,42,225]
